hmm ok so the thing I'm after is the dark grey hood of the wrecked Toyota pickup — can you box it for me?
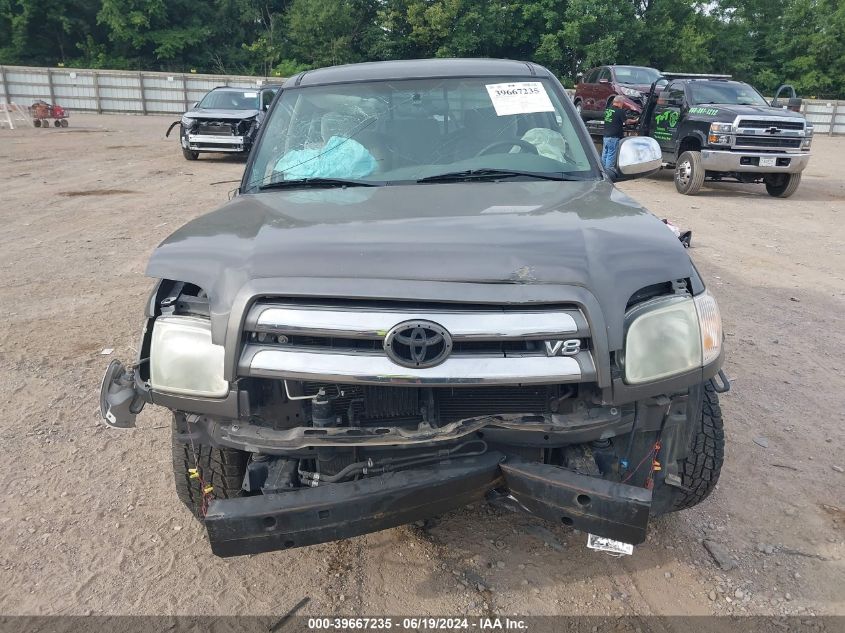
[147,181,697,348]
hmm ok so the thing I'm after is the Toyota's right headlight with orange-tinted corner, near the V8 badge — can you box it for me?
[623,292,722,385]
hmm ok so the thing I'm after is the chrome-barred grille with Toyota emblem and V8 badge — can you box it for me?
[239,300,595,387]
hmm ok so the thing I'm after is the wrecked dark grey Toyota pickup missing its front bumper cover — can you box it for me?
[100,59,729,556]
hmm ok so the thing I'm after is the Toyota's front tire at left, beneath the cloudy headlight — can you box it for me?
[172,413,249,520]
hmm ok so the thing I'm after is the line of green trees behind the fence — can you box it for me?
[0,0,845,97]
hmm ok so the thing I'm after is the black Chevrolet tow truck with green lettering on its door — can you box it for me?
[639,74,813,198]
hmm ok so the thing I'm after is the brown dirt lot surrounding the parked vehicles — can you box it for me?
[0,116,845,615]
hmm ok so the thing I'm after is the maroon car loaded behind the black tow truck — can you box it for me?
[573,66,660,120]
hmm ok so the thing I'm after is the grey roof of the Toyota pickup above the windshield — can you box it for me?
[284,59,552,88]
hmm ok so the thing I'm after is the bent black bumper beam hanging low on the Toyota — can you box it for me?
[205,452,651,557]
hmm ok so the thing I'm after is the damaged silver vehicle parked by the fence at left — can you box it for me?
[165,86,279,160]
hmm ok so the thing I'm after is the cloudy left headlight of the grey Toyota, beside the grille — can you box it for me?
[150,316,229,398]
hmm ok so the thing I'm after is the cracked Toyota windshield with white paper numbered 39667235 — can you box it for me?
[245,77,599,192]
